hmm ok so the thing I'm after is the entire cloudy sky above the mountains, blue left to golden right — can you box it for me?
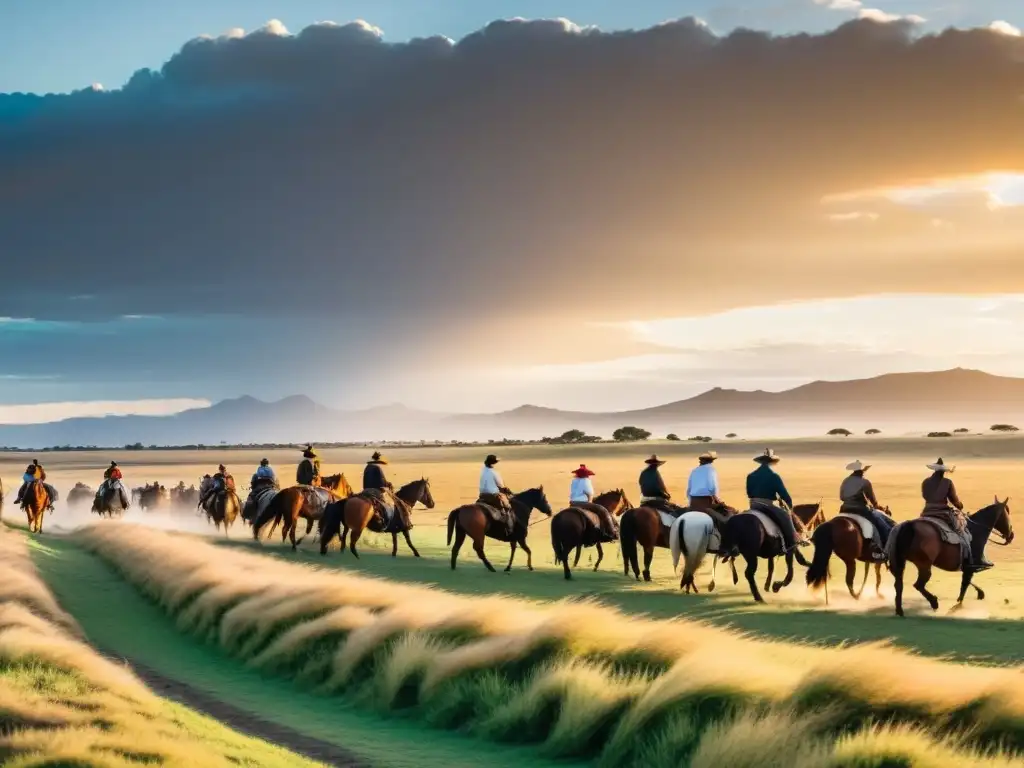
[0,0,1024,423]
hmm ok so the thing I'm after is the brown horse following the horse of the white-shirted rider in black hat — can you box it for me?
[319,477,434,557]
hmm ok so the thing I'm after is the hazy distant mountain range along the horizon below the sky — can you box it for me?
[0,369,1024,449]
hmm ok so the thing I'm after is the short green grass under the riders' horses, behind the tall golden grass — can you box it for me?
[224,526,1024,665]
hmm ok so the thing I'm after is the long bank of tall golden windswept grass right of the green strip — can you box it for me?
[78,525,1024,767]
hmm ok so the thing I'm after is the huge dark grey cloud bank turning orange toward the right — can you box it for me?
[0,14,1024,346]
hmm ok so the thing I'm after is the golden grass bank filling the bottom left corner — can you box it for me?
[0,527,321,768]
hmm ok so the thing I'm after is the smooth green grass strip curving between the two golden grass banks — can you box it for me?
[25,537,585,768]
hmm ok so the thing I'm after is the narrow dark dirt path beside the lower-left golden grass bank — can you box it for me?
[106,654,370,768]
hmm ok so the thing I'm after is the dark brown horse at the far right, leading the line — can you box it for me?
[887,497,1014,616]
